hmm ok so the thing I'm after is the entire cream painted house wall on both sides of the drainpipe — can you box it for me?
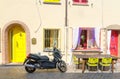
[0,0,120,64]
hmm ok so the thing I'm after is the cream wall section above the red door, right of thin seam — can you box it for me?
[103,0,120,27]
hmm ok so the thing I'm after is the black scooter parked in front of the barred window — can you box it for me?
[23,48,67,73]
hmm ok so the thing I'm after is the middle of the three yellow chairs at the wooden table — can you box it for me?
[87,58,99,71]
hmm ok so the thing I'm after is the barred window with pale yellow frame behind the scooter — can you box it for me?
[44,29,60,51]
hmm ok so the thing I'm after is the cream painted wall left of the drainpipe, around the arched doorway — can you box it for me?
[0,0,65,63]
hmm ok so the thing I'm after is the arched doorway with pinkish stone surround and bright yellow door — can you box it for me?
[2,20,30,64]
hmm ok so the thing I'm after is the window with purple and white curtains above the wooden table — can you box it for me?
[73,28,100,50]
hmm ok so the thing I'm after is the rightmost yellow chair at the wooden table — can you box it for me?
[100,58,112,71]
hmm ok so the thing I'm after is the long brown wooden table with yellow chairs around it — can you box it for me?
[74,54,118,73]
